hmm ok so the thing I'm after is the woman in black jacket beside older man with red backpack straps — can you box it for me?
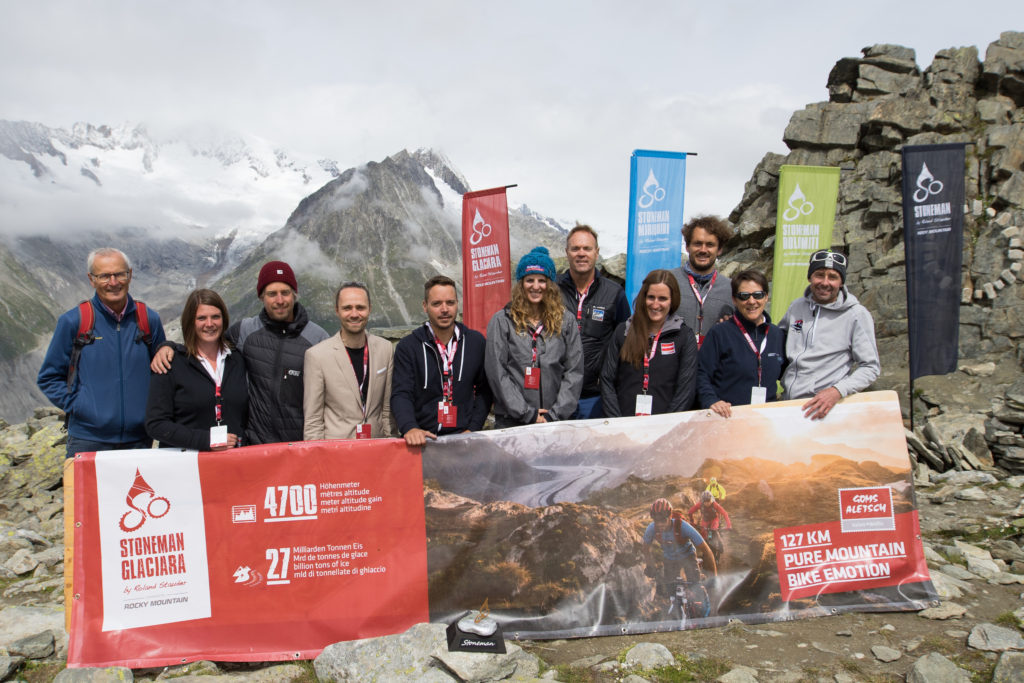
[145,289,249,451]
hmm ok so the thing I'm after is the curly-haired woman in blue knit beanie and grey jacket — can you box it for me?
[484,247,583,429]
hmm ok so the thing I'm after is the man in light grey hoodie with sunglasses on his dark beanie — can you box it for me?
[778,249,881,420]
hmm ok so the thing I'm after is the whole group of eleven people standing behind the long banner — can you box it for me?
[38,211,879,457]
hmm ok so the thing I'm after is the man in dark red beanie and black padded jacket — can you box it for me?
[152,261,330,445]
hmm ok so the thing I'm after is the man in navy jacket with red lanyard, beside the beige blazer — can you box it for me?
[391,275,492,445]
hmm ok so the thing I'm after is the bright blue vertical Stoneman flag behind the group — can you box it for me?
[626,150,686,306]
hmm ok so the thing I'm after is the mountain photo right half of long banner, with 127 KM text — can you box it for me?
[424,391,937,639]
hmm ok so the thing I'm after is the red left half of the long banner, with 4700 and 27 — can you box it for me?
[68,439,428,668]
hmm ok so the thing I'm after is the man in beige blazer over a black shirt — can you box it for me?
[302,283,394,441]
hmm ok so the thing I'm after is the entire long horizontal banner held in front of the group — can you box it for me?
[69,392,937,667]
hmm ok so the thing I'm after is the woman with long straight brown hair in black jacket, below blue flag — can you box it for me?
[601,270,697,417]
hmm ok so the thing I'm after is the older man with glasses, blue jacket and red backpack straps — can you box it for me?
[36,248,164,458]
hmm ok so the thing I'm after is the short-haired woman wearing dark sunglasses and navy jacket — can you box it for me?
[697,270,785,418]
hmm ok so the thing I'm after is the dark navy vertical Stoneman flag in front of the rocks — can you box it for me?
[902,142,964,382]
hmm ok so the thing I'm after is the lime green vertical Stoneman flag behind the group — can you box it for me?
[771,166,839,322]
